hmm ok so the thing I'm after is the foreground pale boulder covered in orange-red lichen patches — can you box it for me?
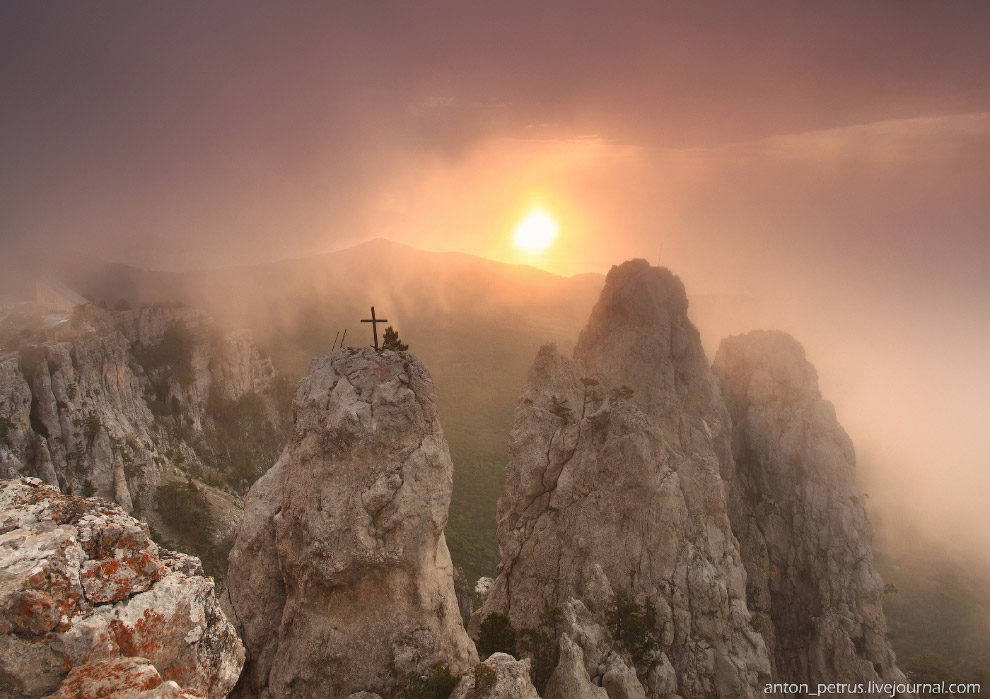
[0,479,244,699]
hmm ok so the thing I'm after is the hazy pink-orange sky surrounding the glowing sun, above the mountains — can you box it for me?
[0,0,990,548]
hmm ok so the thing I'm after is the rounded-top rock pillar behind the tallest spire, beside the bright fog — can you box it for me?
[714,331,904,686]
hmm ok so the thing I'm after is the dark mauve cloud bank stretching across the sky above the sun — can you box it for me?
[0,0,990,265]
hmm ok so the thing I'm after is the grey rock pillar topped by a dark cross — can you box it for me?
[228,348,477,699]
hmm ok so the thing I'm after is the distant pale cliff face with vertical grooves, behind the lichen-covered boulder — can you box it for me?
[0,308,281,576]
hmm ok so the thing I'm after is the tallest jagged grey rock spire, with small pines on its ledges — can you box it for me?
[472,260,770,699]
